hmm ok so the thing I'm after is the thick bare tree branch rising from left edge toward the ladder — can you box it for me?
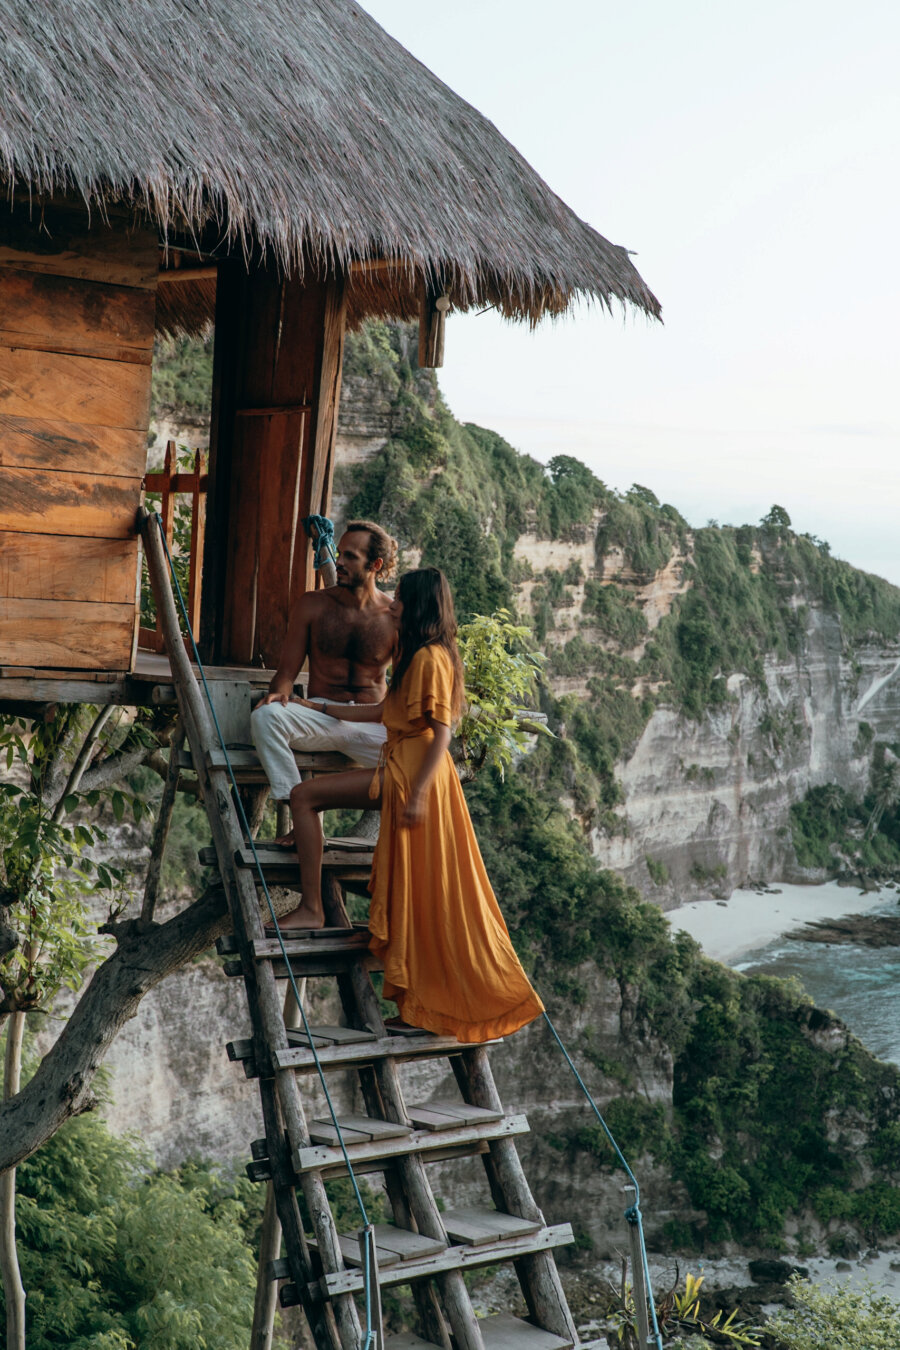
[0,890,231,1173]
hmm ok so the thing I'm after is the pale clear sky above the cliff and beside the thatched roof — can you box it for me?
[363,0,900,585]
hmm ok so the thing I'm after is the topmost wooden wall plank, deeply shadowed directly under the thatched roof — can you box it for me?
[0,204,159,290]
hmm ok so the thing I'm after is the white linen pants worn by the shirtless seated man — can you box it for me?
[250,703,387,802]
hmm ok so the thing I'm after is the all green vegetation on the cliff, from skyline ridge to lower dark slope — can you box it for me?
[144,324,900,1249]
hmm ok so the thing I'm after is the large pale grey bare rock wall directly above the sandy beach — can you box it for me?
[592,606,900,909]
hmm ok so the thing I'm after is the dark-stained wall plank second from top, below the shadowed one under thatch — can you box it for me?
[0,267,155,363]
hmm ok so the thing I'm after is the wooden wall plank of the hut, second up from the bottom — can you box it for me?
[0,531,139,605]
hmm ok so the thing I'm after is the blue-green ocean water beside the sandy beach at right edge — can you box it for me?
[729,892,900,1064]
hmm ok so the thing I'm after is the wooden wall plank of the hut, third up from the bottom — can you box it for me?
[0,468,140,539]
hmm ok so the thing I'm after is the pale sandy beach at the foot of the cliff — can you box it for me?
[667,882,899,965]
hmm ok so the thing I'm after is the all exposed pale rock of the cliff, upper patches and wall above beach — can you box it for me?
[335,374,900,909]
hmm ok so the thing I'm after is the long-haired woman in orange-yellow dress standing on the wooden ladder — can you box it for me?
[282,567,544,1042]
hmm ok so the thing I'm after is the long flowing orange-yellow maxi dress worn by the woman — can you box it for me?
[368,645,544,1042]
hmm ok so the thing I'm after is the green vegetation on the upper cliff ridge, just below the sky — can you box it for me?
[337,324,900,830]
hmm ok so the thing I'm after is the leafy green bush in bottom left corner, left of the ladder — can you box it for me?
[11,1115,263,1350]
